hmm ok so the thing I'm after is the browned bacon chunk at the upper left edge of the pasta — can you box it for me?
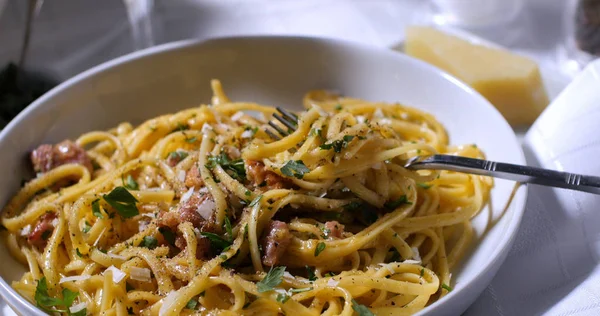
[31,140,94,173]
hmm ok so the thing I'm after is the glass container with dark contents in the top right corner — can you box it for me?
[558,0,600,76]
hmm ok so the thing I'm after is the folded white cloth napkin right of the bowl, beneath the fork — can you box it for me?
[466,60,600,315]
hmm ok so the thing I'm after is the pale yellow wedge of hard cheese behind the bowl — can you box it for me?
[405,26,549,126]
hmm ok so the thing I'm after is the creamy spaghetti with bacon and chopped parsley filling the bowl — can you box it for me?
[2,81,492,315]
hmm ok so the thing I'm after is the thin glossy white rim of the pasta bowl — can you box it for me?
[0,35,529,316]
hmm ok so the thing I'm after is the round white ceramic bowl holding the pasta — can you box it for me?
[0,37,526,315]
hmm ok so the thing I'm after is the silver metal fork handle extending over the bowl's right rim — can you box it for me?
[406,155,600,194]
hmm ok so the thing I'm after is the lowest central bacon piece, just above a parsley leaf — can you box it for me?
[262,221,292,266]
